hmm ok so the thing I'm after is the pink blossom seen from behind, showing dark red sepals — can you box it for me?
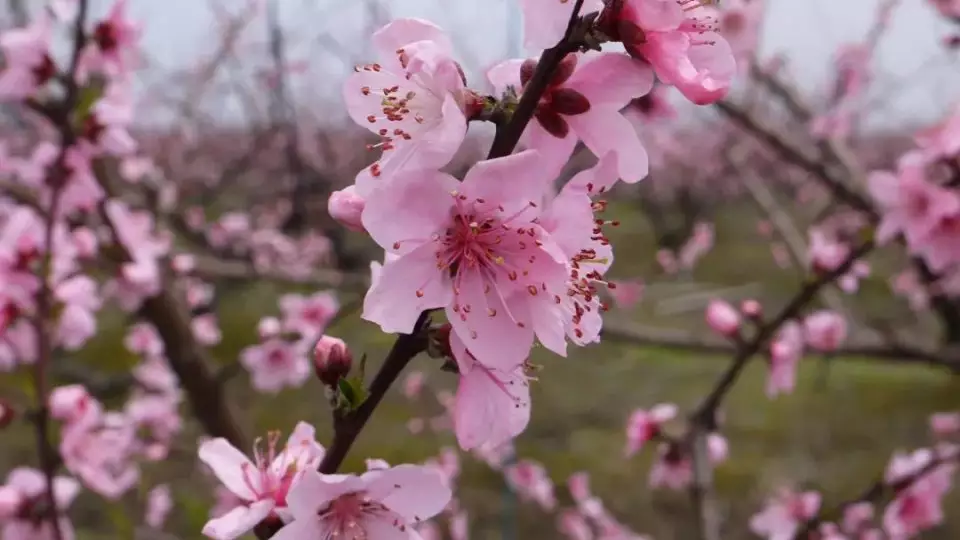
[487,53,653,183]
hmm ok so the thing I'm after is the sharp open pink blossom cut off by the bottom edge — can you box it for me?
[273,465,451,540]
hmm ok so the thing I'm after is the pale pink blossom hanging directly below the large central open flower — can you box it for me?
[450,332,530,450]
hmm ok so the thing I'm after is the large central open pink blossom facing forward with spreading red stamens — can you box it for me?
[363,150,568,372]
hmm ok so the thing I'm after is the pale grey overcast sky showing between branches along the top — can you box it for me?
[77,0,960,129]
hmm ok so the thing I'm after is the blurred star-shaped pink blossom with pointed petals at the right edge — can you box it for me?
[867,154,960,246]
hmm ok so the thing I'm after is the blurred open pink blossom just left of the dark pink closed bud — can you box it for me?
[240,338,312,393]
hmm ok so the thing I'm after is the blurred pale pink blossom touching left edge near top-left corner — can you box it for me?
[0,16,57,101]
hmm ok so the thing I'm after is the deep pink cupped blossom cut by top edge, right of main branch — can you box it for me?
[600,0,737,105]
